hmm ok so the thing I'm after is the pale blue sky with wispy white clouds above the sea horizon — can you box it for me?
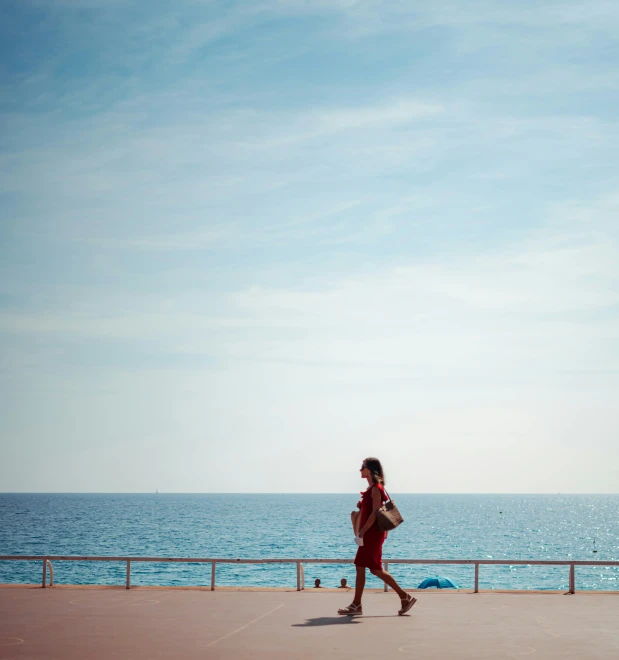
[0,0,619,493]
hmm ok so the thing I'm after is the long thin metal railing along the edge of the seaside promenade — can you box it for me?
[0,555,619,594]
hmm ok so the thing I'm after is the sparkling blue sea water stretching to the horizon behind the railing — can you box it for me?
[0,493,619,590]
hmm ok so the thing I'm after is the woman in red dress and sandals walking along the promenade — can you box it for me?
[338,458,417,616]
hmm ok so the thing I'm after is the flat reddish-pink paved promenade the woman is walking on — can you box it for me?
[0,586,619,660]
